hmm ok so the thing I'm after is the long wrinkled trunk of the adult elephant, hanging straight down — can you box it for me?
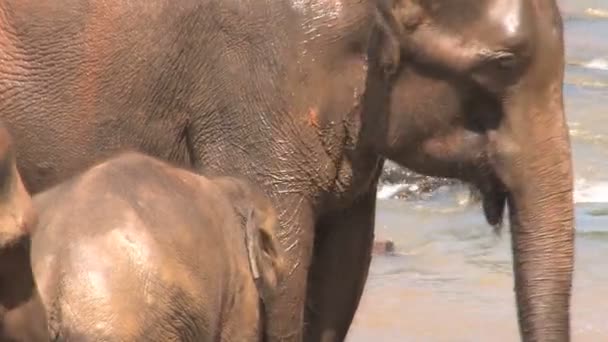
[493,75,574,341]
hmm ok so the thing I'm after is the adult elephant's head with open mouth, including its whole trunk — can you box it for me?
[362,0,574,341]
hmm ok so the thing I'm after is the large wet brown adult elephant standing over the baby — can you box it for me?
[0,0,573,341]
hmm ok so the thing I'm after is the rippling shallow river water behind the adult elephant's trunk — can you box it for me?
[348,0,608,342]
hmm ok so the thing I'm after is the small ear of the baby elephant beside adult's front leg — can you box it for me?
[245,207,285,304]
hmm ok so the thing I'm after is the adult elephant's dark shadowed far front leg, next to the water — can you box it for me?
[305,192,376,342]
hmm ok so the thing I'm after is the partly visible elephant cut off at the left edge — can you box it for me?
[0,123,48,342]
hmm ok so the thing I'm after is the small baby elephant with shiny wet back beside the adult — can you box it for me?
[32,152,283,342]
